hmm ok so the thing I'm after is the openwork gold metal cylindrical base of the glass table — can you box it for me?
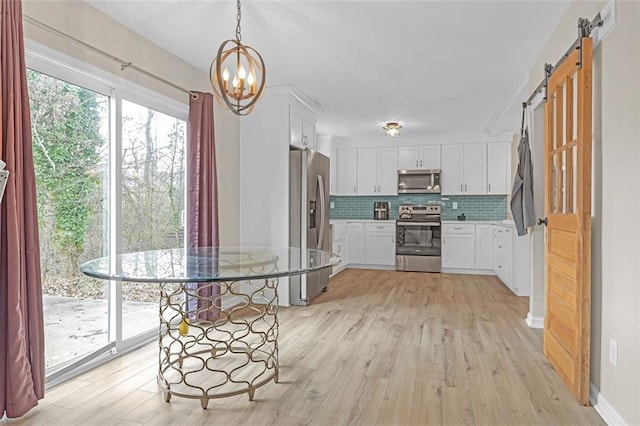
[158,278,279,409]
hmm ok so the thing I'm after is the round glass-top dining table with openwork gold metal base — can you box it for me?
[80,247,340,408]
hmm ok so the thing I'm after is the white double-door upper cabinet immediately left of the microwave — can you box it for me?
[358,148,398,195]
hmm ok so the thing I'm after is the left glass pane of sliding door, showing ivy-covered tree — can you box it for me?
[27,70,110,369]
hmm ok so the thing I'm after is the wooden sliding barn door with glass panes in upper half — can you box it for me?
[544,38,593,405]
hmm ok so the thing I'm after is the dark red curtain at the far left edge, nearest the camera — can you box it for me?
[0,0,45,417]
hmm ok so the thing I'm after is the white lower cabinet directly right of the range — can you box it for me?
[442,224,476,269]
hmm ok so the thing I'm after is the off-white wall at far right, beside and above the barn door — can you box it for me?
[530,0,640,424]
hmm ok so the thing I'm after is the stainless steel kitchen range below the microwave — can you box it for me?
[396,204,442,272]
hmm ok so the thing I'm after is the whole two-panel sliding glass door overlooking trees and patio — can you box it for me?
[27,57,186,378]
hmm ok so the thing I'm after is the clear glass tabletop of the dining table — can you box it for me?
[80,246,340,283]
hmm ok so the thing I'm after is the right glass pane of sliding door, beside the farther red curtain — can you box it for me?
[122,100,186,339]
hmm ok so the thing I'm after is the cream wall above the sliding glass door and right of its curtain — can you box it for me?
[23,0,239,245]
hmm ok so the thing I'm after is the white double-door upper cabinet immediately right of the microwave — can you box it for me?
[442,143,487,195]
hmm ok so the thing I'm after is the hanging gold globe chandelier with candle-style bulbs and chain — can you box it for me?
[209,0,266,115]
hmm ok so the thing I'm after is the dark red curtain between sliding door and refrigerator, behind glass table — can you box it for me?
[187,92,220,321]
